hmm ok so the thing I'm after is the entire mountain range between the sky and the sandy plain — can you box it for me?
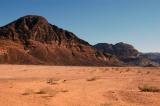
[0,15,160,66]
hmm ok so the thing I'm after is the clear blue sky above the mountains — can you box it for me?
[0,0,160,52]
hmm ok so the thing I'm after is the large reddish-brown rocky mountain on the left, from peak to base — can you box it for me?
[0,15,120,66]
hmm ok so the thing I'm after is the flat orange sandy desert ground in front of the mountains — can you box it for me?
[0,65,160,106]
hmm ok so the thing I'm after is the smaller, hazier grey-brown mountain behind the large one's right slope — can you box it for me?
[94,42,159,66]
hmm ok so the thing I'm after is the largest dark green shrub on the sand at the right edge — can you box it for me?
[138,85,160,92]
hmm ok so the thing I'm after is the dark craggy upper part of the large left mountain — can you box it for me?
[0,15,89,45]
